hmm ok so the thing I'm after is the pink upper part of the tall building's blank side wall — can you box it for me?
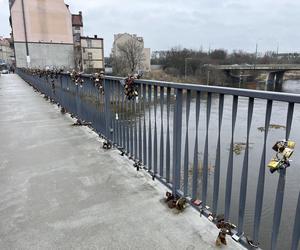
[11,0,73,44]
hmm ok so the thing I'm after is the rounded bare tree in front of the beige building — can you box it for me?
[118,39,144,73]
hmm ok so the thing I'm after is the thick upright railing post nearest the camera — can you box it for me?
[172,89,182,194]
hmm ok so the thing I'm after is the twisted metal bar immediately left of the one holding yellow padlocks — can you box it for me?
[253,100,273,244]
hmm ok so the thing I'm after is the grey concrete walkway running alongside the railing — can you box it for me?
[0,75,243,250]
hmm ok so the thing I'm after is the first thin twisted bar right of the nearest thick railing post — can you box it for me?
[183,90,191,196]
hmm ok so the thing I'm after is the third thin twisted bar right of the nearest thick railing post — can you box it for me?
[202,93,211,207]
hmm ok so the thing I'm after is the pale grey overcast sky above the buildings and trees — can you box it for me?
[0,0,300,55]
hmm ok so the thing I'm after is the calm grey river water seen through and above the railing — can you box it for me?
[138,80,300,249]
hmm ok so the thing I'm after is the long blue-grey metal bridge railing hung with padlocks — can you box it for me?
[18,69,300,250]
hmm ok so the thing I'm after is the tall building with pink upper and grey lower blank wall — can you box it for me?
[10,0,74,68]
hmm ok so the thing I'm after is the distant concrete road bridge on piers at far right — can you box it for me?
[209,64,300,84]
